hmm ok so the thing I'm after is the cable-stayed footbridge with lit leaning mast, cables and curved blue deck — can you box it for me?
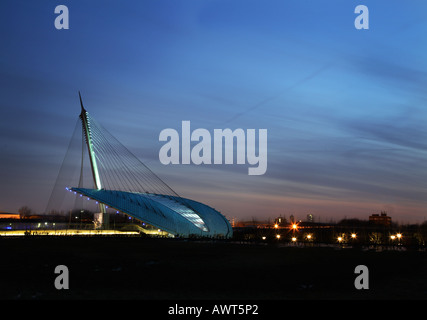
[48,92,232,238]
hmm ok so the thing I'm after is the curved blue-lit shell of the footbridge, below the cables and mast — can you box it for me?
[70,188,232,238]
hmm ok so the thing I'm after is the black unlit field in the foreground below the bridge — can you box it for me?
[0,236,427,300]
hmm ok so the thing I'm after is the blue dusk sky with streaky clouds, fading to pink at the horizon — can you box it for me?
[0,0,427,223]
